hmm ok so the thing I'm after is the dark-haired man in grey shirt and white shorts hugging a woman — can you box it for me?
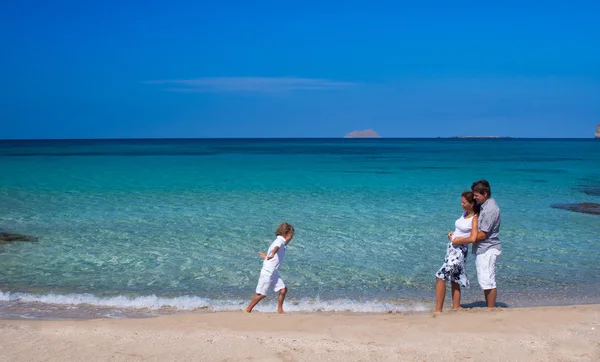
[471,180,502,308]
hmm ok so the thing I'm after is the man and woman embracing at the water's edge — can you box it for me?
[435,180,502,312]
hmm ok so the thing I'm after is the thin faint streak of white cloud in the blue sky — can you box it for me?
[145,77,354,93]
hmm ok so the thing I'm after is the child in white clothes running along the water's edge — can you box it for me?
[245,222,294,313]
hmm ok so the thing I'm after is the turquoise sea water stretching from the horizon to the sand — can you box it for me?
[0,139,600,318]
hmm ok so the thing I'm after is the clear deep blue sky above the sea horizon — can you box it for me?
[0,0,600,139]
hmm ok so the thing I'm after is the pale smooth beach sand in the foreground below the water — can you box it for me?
[0,305,600,361]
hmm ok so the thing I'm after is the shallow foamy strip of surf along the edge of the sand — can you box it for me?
[0,290,600,320]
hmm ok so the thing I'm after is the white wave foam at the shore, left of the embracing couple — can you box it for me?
[0,291,429,313]
